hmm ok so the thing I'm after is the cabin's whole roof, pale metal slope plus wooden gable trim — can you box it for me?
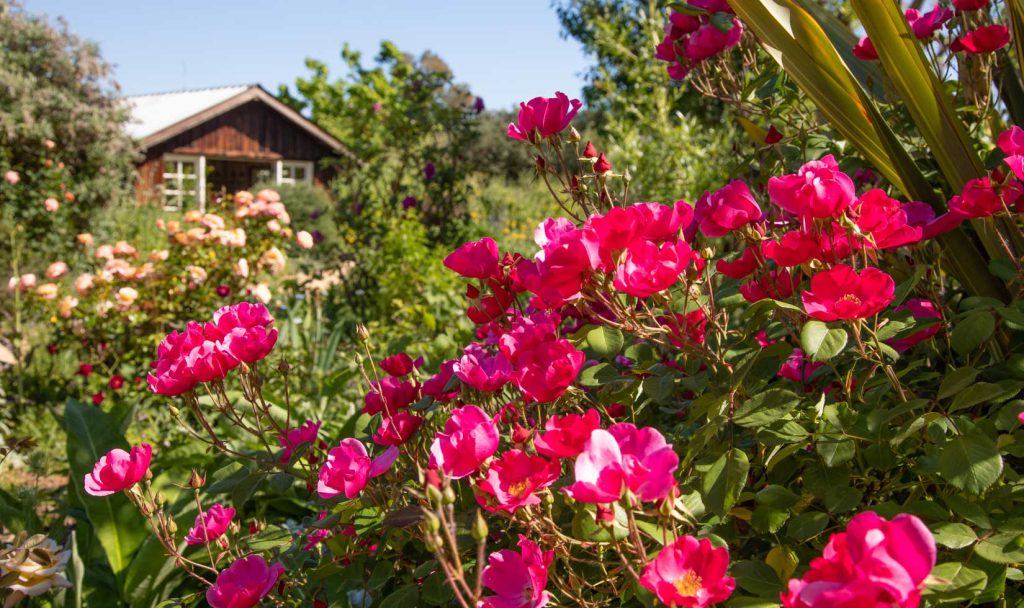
[125,85,351,156]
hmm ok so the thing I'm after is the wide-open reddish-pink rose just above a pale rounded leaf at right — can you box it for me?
[800,264,896,321]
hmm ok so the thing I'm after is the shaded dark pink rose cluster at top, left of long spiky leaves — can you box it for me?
[654,0,743,80]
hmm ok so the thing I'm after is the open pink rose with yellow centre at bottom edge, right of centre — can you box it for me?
[640,536,736,608]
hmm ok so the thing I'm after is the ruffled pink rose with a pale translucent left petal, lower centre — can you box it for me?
[565,423,679,504]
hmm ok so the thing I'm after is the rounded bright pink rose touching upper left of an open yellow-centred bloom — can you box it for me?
[429,405,499,479]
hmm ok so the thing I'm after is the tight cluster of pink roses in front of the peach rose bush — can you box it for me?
[147,302,278,396]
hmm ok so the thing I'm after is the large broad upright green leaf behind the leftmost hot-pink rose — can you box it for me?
[63,399,146,577]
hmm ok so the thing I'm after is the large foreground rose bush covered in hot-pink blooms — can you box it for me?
[6,0,1024,608]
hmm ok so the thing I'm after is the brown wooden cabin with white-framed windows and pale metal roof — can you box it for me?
[126,85,351,211]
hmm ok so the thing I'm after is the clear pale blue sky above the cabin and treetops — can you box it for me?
[25,0,587,107]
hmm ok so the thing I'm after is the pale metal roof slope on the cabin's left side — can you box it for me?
[125,85,255,139]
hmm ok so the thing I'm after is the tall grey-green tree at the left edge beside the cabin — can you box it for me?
[0,1,135,268]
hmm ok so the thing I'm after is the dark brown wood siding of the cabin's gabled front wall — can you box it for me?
[136,100,335,202]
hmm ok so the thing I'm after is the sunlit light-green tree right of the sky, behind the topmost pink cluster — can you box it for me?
[555,0,734,201]
